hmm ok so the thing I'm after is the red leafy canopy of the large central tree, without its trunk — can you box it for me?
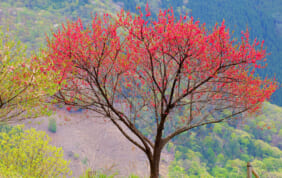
[45,9,276,114]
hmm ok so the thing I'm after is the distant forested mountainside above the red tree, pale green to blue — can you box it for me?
[0,0,282,106]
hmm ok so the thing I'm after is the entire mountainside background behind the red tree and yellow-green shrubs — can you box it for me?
[0,0,282,178]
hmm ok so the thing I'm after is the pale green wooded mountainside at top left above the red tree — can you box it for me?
[0,0,118,50]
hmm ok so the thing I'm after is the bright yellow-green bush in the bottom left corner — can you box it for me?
[0,126,71,178]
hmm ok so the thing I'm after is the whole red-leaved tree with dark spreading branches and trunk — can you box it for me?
[46,9,277,178]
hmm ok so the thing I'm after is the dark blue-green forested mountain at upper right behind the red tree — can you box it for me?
[114,0,282,106]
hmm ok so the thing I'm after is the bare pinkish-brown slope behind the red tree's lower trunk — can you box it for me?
[19,109,173,177]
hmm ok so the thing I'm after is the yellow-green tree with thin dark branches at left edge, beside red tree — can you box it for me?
[0,28,59,122]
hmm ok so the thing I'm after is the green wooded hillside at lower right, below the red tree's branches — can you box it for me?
[168,103,282,178]
